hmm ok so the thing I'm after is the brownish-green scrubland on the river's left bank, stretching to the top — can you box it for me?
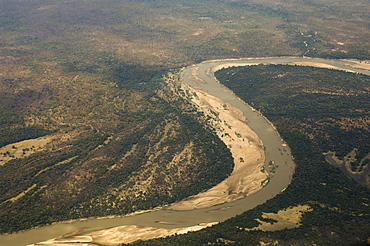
[0,0,370,240]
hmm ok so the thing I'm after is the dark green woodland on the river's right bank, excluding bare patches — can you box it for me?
[125,65,370,245]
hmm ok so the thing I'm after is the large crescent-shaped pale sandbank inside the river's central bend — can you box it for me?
[168,85,267,210]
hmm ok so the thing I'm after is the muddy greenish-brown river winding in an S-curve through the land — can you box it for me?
[0,57,370,246]
